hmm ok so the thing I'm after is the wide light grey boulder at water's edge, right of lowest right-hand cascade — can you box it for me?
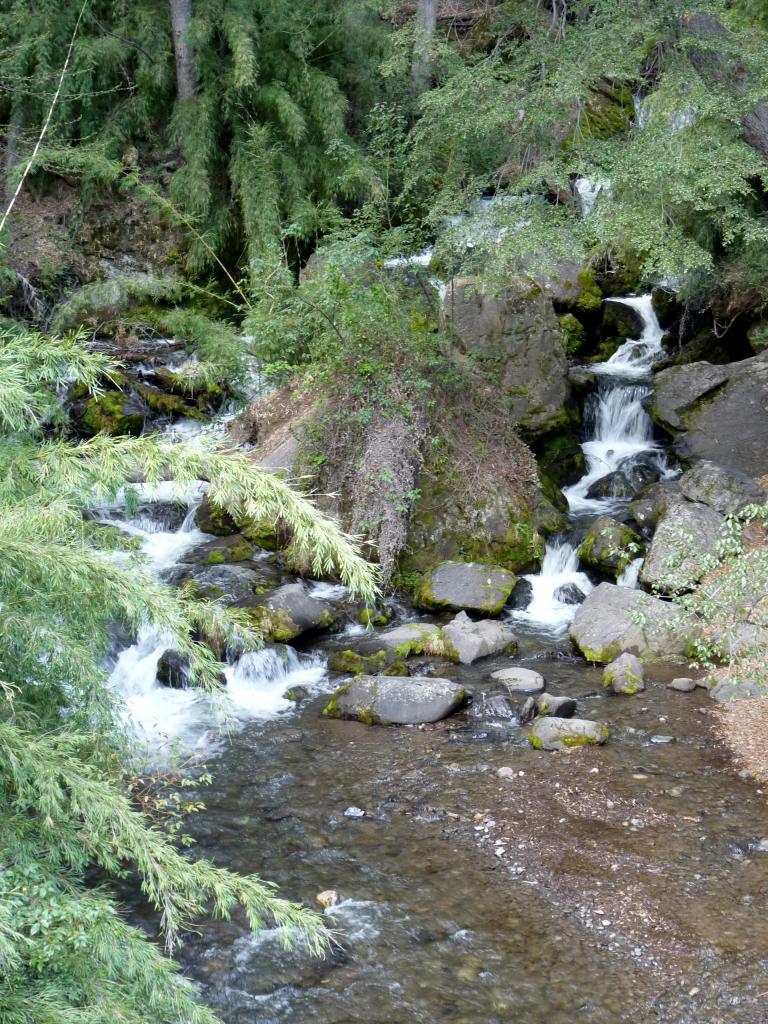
[570,583,691,665]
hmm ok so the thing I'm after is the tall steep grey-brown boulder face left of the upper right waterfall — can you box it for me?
[443,278,570,437]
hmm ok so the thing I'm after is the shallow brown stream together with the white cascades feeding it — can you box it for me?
[109,296,768,1024]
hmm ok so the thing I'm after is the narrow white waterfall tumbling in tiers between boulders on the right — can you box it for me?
[512,292,672,633]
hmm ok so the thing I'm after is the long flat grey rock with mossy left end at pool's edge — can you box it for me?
[323,676,468,725]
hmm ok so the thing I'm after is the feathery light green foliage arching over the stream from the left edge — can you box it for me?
[0,321,376,1024]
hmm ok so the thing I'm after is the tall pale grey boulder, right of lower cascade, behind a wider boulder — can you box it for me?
[640,502,723,591]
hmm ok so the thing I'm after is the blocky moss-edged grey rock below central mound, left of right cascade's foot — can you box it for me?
[414,562,515,615]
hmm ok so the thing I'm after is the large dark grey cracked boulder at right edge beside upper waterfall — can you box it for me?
[652,351,768,477]
